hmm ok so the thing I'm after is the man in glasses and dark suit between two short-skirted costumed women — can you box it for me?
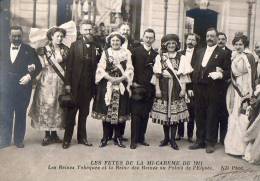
[130,29,158,149]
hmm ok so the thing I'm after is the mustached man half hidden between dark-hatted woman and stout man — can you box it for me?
[176,33,199,142]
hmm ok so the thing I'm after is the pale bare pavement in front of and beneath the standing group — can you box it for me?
[0,101,260,181]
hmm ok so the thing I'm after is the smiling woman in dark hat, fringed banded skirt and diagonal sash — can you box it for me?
[151,34,190,150]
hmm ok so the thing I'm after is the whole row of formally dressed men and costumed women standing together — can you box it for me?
[0,20,260,162]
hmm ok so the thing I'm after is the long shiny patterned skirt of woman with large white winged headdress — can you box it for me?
[29,66,65,131]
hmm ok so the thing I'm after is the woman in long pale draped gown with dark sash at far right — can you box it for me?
[224,34,256,156]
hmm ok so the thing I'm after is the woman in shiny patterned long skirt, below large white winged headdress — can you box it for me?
[29,27,69,146]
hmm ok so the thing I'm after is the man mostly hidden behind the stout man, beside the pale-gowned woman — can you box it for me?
[215,32,232,145]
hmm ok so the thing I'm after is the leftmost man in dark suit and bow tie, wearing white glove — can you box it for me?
[0,26,41,148]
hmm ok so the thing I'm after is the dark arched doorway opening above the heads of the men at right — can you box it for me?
[186,8,218,46]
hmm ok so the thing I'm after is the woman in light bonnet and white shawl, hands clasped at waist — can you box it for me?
[92,32,134,148]
